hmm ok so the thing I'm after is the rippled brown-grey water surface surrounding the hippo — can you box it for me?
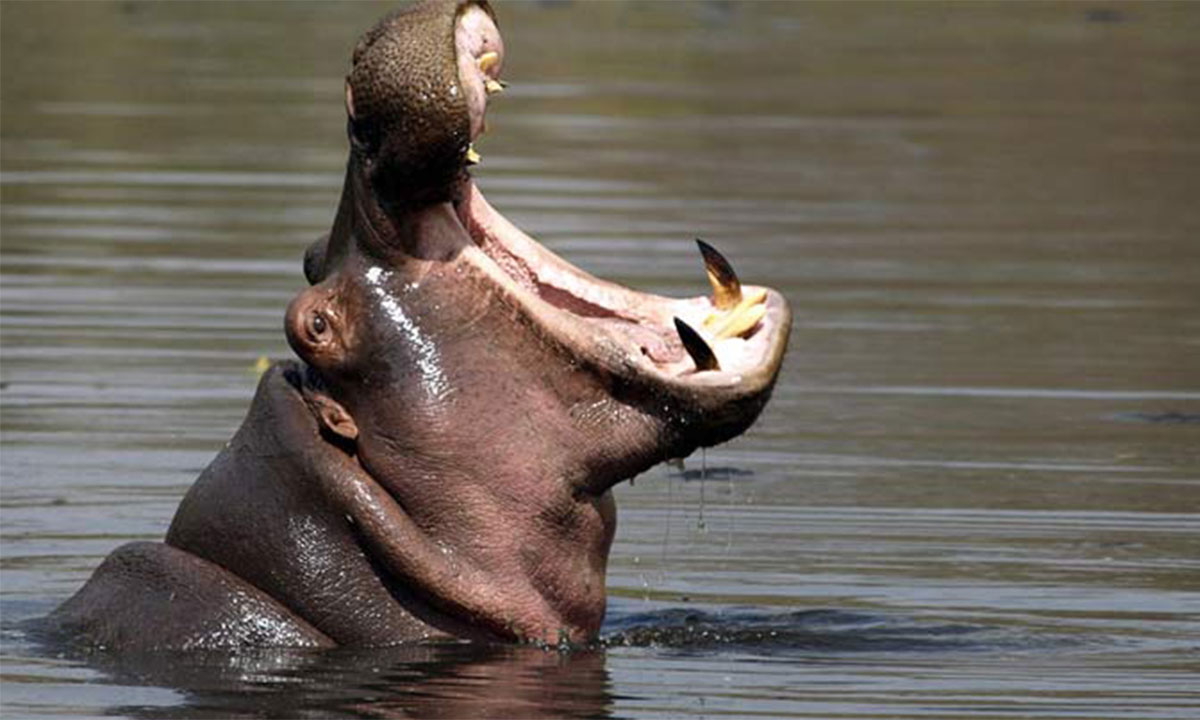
[0,1,1200,719]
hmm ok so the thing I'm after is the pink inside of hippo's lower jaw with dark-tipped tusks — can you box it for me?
[455,179,790,386]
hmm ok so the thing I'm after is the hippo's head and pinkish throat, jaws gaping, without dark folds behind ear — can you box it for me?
[286,0,791,642]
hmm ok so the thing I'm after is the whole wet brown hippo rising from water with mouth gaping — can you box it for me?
[48,0,791,650]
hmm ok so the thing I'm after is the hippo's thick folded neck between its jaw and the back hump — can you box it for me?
[167,362,614,644]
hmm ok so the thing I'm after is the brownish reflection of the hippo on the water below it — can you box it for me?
[81,644,612,719]
